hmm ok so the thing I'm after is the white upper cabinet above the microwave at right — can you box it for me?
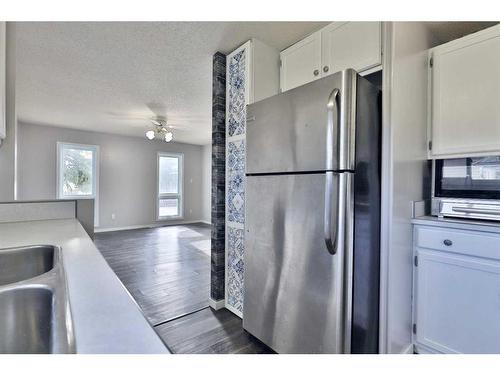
[428,26,500,158]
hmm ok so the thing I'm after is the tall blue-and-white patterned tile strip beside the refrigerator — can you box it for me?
[226,43,250,316]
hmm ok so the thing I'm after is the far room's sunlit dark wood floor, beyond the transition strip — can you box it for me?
[95,224,210,325]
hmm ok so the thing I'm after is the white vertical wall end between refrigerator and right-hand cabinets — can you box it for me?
[380,22,436,353]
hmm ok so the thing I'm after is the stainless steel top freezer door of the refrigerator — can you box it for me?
[246,69,357,174]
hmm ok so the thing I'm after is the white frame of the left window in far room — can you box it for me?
[56,142,100,227]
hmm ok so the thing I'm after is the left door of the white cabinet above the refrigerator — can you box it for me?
[280,32,321,91]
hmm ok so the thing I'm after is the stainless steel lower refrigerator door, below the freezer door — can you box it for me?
[243,173,352,353]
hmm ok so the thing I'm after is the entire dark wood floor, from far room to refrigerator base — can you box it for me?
[95,224,271,354]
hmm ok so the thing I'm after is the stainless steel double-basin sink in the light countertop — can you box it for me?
[0,245,76,354]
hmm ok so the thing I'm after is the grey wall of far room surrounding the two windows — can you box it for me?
[18,123,209,229]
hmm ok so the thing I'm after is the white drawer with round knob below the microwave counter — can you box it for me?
[414,226,500,259]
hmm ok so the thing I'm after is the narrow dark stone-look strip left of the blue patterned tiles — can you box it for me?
[210,52,226,301]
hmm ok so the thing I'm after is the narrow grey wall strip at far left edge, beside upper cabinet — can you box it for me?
[0,22,17,202]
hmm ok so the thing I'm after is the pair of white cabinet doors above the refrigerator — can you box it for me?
[280,22,382,91]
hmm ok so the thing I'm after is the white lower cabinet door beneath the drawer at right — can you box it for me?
[414,248,500,353]
